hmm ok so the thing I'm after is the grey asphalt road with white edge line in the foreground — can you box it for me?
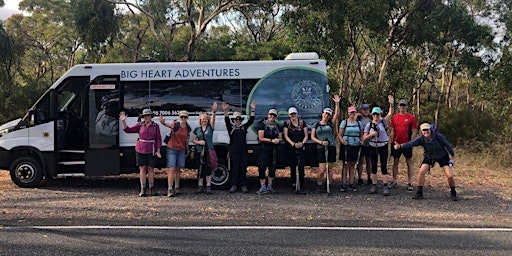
[0,226,512,256]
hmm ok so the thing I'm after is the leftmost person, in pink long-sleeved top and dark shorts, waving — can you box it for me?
[119,109,162,197]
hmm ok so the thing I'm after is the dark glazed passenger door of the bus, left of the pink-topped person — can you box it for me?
[85,76,121,176]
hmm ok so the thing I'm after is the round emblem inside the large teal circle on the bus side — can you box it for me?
[292,80,323,109]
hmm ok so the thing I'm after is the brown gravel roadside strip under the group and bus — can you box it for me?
[0,169,512,228]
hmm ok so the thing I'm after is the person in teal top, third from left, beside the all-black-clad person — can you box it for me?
[192,101,217,195]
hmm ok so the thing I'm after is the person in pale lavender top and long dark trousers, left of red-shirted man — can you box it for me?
[363,95,394,196]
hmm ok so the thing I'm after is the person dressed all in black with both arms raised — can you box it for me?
[222,101,256,193]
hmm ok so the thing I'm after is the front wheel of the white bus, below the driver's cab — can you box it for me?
[10,157,44,188]
